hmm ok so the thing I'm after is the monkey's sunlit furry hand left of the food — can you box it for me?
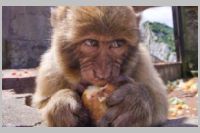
[42,89,89,127]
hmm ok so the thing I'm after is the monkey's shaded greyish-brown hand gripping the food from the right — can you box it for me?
[98,77,152,127]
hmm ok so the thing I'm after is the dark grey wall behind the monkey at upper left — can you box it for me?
[2,6,51,68]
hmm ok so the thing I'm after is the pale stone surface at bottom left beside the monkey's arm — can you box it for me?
[2,90,43,127]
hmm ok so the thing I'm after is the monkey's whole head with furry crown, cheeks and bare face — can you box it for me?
[51,6,139,86]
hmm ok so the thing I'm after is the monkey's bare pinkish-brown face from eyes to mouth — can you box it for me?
[79,37,128,86]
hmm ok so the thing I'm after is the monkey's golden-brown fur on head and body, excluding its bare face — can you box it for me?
[33,7,167,126]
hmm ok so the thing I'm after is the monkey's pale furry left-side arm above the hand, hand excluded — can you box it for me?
[33,50,67,109]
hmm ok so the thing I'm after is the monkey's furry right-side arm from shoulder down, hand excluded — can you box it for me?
[132,45,168,125]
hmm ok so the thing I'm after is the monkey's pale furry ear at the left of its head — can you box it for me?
[50,6,69,27]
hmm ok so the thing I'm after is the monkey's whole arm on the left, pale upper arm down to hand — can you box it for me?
[33,52,89,126]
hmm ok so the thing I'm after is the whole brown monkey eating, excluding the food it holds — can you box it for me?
[33,6,168,126]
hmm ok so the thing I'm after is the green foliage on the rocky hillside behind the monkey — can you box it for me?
[143,21,175,52]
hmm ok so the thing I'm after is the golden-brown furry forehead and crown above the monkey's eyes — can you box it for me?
[65,6,138,42]
